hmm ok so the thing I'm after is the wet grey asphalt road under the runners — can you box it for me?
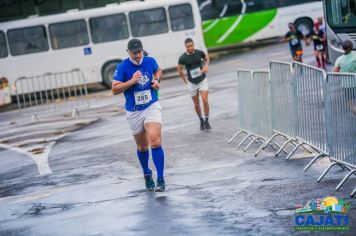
[0,44,356,235]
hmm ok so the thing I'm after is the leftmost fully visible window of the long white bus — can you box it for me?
[7,26,49,56]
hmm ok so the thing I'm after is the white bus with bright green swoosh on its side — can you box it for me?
[198,0,324,49]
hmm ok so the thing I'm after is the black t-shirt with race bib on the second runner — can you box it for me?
[178,49,206,84]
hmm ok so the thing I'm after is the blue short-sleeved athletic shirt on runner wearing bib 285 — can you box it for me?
[113,56,159,111]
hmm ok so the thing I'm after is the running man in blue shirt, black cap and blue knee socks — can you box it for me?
[112,39,165,192]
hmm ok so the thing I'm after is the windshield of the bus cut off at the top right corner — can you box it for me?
[325,0,356,28]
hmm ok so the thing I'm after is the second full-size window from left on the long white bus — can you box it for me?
[49,20,89,49]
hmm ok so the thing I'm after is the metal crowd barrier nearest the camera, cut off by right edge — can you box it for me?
[318,73,356,196]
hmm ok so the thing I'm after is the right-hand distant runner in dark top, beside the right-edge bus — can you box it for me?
[309,22,326,69]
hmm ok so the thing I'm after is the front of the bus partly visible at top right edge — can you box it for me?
[324,0,356,64]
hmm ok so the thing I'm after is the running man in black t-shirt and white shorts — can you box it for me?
[177,38,211,130]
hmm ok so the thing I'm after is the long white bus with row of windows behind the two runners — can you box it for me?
[0,0,206,95]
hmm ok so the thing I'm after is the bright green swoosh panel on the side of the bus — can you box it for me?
[203,9,277,48]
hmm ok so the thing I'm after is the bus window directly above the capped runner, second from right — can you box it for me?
[129,8,168,37]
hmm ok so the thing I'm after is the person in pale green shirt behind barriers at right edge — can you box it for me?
[333,40,356,113]
